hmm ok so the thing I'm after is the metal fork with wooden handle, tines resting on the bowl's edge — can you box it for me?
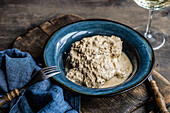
[0,66,60,107]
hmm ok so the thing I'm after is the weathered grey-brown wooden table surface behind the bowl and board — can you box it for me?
[0,0,170,112]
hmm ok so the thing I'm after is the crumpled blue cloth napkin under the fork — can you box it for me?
[0,49,80,113]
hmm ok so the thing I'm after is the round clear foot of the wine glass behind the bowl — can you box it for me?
[134,26,165,50]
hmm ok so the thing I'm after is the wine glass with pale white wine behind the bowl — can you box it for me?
[134,0,170,50]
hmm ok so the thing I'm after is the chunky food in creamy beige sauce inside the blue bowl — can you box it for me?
[66,35,132,88]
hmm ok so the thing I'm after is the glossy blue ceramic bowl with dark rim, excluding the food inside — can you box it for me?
[44,19,154,95]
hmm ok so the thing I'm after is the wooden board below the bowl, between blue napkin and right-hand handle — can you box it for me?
[81,84,149,113]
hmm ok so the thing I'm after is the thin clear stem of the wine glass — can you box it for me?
[144,10,153,38]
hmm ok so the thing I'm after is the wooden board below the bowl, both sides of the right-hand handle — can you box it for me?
[81,70,170,113]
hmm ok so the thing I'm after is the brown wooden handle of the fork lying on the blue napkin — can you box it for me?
[0,89,19,107]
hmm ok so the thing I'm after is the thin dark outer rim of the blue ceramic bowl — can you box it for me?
[43,18,155,96]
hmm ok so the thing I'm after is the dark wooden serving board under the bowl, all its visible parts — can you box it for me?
[13,15,170,113]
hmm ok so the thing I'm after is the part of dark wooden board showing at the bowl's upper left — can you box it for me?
[13,14,83,60]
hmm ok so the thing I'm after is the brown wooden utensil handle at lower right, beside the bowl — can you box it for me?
[150,80,169,113]
